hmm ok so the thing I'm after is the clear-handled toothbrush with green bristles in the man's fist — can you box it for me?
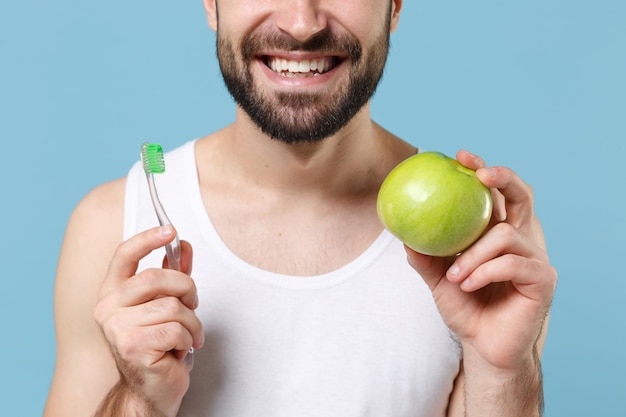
[141,142,193,370]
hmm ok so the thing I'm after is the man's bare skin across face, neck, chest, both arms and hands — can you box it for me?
[44,0,556,417]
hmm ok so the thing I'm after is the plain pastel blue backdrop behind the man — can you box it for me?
[0,0,626,417]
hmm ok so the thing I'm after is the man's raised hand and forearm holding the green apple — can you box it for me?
[407,152,557,417]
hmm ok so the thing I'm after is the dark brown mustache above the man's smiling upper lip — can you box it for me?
[241,29,362,62]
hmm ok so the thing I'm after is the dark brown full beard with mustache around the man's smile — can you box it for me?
[217,12,390,144]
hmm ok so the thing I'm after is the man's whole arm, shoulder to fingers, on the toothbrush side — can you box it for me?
[45,176,203,417]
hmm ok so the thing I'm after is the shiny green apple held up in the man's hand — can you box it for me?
[376,152,493,256]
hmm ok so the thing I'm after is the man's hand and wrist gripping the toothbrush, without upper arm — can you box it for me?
[94,226,204,416]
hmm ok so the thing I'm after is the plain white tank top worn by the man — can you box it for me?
[124,141,461,417]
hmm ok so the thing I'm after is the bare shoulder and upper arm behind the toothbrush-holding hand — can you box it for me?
[44,179,126,416]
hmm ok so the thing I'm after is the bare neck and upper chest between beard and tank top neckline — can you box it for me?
[196,104,415,275]
